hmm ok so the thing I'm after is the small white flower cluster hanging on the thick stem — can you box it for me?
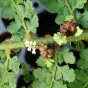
[25,39,37,54]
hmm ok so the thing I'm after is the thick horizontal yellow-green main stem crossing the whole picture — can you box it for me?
[0,32,88,50]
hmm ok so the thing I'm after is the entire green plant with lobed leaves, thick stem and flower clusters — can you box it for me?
[0,0,88,88]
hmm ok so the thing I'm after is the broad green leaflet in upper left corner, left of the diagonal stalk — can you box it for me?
[1,2,16,19]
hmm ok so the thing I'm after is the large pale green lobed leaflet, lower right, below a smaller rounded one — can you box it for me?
[61,65,75,82]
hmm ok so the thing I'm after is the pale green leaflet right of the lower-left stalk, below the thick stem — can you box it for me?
[9,56,20,74]
